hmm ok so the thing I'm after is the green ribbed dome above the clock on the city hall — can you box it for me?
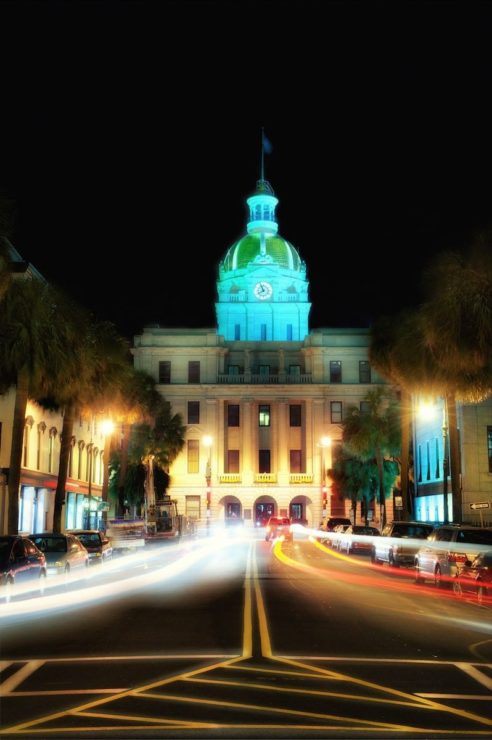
[222,234,302,272]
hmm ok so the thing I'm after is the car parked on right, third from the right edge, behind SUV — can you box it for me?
[371,521,434,568]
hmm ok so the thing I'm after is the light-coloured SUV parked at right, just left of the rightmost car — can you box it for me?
[415,524,492,586]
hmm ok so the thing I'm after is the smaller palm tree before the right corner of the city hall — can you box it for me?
[343,388,401,527]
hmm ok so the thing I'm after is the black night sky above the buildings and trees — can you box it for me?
[0,0,492,337]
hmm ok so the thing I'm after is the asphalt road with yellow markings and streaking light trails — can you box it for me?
[0,537,492,740]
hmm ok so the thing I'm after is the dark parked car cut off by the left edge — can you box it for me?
[0,535,46,600]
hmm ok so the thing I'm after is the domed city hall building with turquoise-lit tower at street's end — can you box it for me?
[133,179,393,527]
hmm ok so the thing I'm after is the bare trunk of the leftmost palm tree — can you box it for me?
[8,366,29,534]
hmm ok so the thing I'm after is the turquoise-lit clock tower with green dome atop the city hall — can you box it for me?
[215,178,311,342]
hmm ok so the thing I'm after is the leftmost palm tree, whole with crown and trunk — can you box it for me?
[0,279,75,533]
